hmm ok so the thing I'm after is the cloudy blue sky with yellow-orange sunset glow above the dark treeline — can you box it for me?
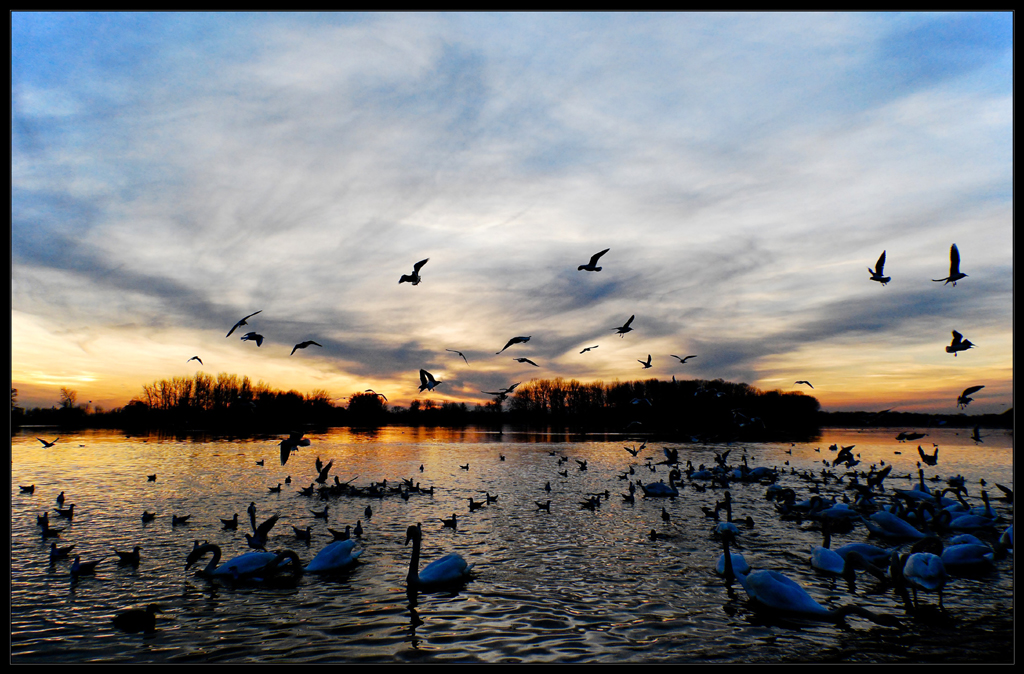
[11,12,1013,414]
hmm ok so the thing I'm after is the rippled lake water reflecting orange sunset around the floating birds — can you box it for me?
[10,427,1014,664]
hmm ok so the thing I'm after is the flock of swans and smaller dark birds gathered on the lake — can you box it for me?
[22,419,1013,633]
